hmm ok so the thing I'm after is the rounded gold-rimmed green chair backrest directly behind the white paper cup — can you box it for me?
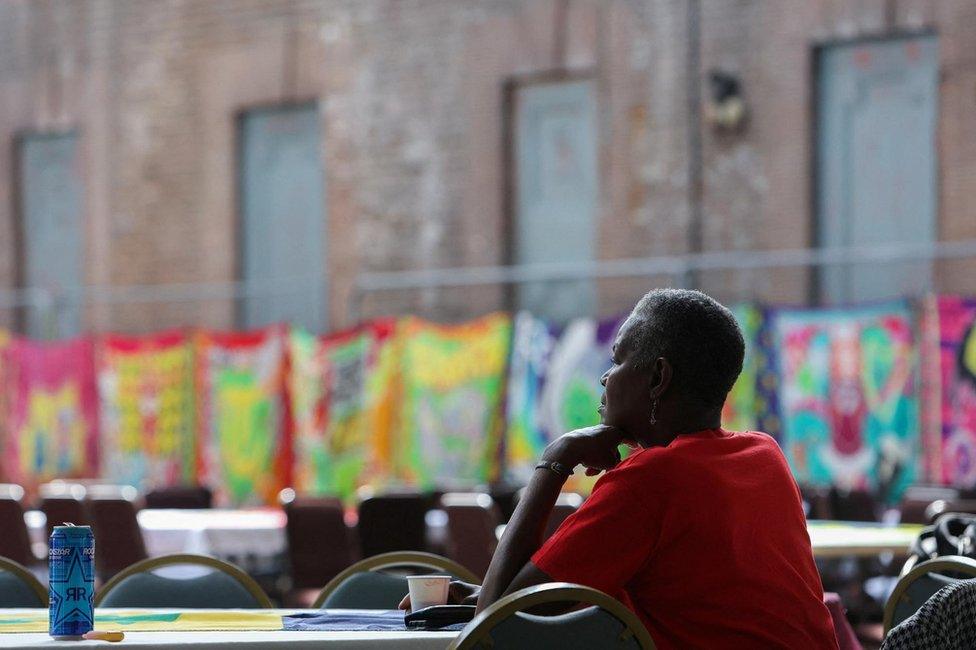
[312,551,479,609]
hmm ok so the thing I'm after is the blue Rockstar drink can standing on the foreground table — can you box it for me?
[48,526,95,638]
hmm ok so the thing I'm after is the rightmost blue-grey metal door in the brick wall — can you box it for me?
[817,36,939,303]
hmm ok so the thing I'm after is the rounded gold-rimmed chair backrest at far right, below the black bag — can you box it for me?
[883,555,976,634]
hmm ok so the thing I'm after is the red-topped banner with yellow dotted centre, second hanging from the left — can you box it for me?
[98,332,196,489]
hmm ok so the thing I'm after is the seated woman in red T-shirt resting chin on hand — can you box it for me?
[404,289,837,648]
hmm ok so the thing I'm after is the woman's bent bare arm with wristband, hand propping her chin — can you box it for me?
[478,425,621,612]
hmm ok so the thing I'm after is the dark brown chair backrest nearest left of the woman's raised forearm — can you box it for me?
[441,492,502,578]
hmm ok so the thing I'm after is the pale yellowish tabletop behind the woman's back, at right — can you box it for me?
[807,520,923,558]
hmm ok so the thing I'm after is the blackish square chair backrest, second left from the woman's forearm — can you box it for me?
[357,493,430,557]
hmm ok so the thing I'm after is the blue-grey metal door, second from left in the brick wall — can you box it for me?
[240,105,328,332]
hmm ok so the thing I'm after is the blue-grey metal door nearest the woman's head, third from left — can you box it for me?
[513,81,599,322]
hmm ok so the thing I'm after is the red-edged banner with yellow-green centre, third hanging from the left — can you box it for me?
[197,327,292,507]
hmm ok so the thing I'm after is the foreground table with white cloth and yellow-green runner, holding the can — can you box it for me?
[0,609,458,650]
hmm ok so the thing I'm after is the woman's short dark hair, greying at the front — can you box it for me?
[627,289,745,406]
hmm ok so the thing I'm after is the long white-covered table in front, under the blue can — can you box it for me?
[0,608,458,650]
